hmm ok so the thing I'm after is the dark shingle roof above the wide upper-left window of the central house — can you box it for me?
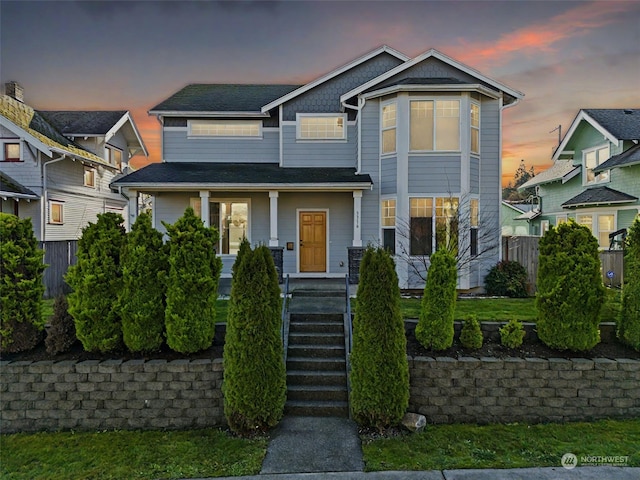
[150,84,301,112]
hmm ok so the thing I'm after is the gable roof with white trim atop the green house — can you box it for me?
[552,108,640,160]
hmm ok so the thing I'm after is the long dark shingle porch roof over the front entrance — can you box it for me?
[113,162,372,186]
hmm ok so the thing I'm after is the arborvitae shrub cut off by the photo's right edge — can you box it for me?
[618,218,640,351]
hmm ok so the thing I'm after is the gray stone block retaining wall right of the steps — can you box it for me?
[409,357,640,423]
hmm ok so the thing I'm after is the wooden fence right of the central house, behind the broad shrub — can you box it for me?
[502,236,624,295]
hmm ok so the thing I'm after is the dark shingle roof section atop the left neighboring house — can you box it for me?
[37,110,127,135]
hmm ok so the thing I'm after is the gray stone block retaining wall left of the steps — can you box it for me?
[0,359,225,433]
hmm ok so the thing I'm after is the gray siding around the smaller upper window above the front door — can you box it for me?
[282,125,358,168]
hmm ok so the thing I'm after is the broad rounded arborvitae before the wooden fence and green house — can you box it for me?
[536,220,605,351]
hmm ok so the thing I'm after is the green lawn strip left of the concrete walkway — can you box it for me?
[0,429,267,480]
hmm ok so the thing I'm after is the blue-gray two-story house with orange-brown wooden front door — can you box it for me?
[113,46,522,289]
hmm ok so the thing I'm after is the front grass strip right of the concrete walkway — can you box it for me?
[362,419,640,471]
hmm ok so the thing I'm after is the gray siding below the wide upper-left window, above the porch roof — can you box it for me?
[162,127,280,163]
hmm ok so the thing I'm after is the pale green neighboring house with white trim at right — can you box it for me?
[520,108,640,249]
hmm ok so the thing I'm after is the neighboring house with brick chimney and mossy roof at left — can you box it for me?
[0,82,147,242]
